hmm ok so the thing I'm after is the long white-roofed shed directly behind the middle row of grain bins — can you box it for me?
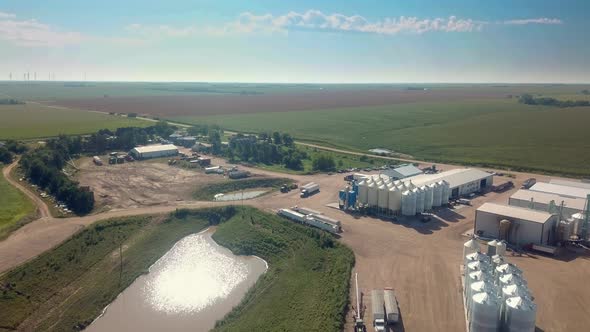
[403,168,494,198]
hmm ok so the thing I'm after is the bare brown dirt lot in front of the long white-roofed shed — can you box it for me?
[77,158,222,211]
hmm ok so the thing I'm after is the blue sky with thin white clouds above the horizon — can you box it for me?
[0,0,590,83]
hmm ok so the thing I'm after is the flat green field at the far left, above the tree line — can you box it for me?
[0,103,153,139]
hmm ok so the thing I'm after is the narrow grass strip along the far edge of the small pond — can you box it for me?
[193,178,293,201]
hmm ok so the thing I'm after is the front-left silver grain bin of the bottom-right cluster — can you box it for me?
[469,293,500,332]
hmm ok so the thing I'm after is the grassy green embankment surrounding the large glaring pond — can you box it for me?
[0,207,354,331]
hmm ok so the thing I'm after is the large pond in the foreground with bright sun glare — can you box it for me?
[86,230,267,332]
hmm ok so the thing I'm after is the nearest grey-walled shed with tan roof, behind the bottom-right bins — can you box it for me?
[474,203,557,246]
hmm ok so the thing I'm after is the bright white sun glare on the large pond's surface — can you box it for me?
[143,234,248,314]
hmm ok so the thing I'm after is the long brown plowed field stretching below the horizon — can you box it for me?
[51,88,504,116]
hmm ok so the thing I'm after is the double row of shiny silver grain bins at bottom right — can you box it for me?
[463,239,537,332]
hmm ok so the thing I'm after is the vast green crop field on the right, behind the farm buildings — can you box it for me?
[177,98,590,177]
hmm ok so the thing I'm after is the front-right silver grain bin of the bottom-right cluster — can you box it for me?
[504,297,537,332]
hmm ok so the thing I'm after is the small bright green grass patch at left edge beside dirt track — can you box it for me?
[0,166,35,240]
